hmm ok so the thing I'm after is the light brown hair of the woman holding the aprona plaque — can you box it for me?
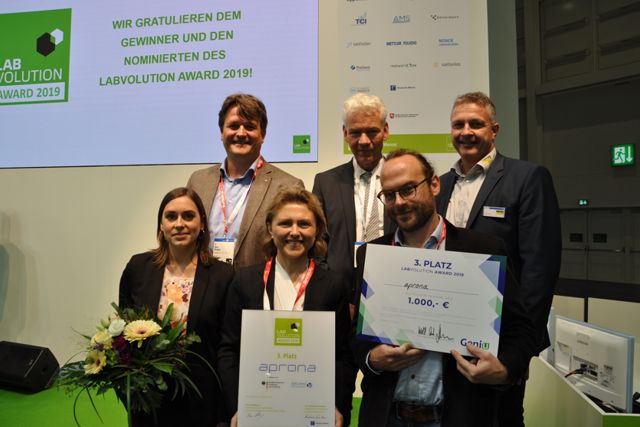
[262,187,327,258]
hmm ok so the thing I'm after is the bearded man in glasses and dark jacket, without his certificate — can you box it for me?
[355,150,535,427]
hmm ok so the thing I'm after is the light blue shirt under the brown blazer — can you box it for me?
[209,158,259,248]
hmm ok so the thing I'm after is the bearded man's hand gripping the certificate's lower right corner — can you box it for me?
[451,344,509,384]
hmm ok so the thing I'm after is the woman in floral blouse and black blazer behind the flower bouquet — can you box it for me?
[119,187,233,427]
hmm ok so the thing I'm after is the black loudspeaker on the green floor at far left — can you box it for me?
[0,341,60,392]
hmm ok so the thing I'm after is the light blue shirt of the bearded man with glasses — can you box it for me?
[394,217,446,405]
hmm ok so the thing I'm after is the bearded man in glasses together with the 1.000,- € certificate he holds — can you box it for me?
[355,150,535,427]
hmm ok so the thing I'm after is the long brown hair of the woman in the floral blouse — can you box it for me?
[151,187,211,267]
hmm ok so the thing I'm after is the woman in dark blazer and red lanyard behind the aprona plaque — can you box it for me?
[218,188,356,427]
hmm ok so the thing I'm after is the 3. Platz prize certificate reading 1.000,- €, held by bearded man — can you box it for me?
[357,244,507,355]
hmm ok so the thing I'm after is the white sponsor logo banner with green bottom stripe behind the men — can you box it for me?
[338,0,489,172]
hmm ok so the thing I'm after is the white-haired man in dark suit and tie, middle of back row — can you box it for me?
[313,93,395,308]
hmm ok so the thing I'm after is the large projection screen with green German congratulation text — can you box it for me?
[0,0,318,168]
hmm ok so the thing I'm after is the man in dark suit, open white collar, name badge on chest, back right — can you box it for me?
[437,92,562,427]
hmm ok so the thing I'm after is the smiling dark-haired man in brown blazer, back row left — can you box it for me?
[187,93,304,267]
